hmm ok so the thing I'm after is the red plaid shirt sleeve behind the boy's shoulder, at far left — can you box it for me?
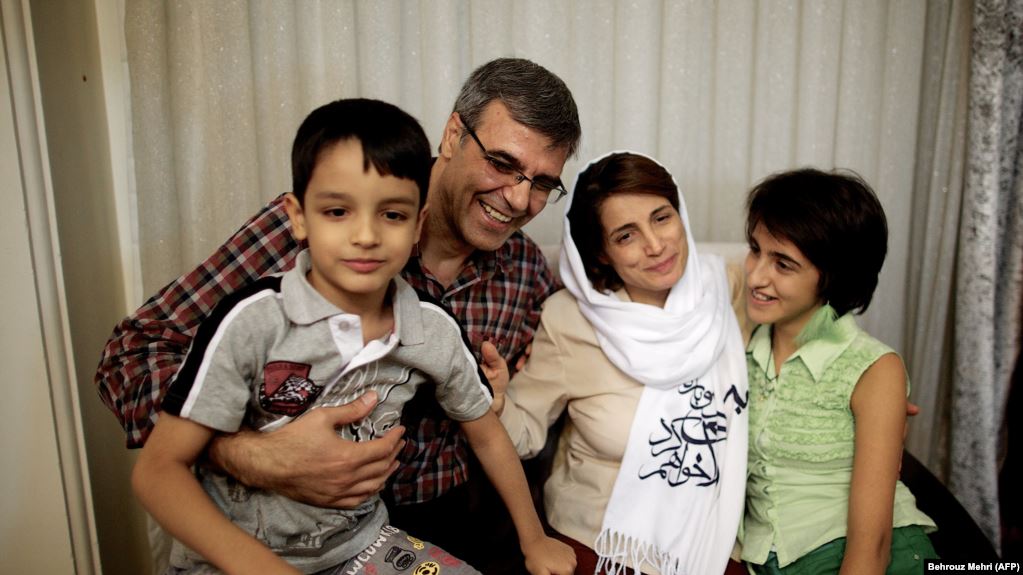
[94,195,301,447]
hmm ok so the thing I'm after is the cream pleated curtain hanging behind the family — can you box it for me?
[125,0,994,544]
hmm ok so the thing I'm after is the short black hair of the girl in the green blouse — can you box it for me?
[746,168,888,316]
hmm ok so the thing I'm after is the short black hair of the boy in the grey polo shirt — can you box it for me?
[292,98,432,208]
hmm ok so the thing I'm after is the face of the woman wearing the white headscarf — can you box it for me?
[599,193,690,307]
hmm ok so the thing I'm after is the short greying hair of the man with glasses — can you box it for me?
[454,58,582,157]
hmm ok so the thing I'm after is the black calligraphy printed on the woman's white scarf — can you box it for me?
[639,379,747,487]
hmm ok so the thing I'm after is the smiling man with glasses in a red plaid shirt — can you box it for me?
[95,58,580,573]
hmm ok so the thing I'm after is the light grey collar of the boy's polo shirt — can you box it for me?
[280,249,425,345]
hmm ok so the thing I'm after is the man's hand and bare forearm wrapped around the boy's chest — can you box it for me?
[209,392,405,508]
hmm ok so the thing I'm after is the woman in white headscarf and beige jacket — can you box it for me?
[501,152,748,575]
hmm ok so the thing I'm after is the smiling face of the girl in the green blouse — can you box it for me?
[746,224,822,336]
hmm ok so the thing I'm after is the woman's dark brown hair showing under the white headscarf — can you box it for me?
[568,152,678,292]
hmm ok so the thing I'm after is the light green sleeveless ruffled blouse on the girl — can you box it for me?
[740,306,934,567]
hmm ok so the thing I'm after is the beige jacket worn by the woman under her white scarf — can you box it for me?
[501,264,750,560]
